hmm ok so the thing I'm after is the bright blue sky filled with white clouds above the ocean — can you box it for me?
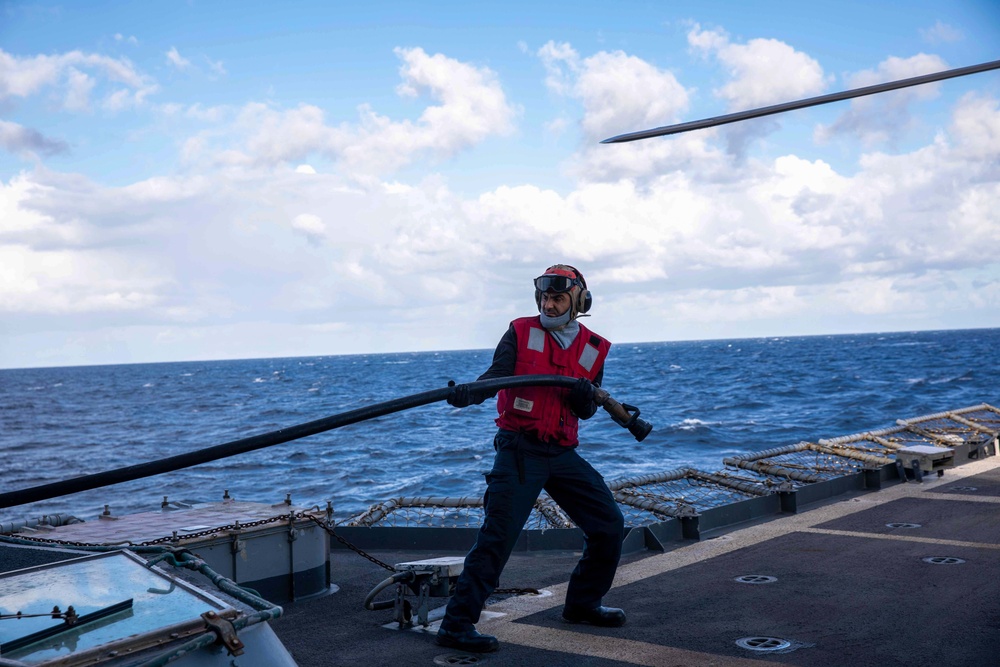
[0,1,1000,367]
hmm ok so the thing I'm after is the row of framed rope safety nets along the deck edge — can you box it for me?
[346,403,1000,530]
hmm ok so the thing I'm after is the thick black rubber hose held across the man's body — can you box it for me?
[0,375,576,508]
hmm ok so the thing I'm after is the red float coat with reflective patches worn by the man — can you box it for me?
[496,315,611,447]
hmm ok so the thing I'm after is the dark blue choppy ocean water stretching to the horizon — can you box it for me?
[0,329,1000,521]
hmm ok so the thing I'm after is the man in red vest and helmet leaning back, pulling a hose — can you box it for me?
[437,264,625,653]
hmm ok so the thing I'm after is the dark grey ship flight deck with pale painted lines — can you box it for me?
[272,456,1000,667]
